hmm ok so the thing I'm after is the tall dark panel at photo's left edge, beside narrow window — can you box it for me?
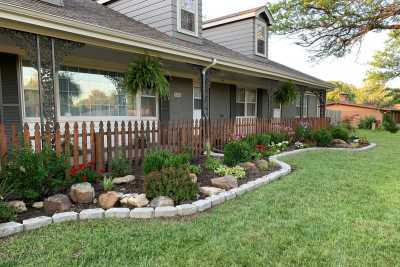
[0,53,22,134]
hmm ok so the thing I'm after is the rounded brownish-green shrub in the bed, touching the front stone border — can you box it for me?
[144,168,198,204]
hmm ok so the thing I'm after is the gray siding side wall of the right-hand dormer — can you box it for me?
[203,18,255,56]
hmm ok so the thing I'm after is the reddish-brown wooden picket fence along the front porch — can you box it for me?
[0,118,329,171]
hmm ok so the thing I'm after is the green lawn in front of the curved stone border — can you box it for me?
[0,132,400,266]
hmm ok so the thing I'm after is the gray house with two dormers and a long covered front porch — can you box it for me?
[0,0,331,135]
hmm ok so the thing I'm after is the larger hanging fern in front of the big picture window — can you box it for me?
[125,56,169,98]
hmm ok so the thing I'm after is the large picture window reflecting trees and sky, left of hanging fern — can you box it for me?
[58,67,138,117]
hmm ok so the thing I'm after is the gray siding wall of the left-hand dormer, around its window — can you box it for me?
[108,0,203,43]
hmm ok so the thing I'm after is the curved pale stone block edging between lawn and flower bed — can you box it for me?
[0,143,377,238]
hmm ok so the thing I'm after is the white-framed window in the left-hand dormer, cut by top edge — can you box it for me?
[177,0,199,36]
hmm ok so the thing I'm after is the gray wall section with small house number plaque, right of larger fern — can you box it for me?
[169,77,193,121]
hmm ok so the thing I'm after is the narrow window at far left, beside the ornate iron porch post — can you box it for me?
[22,62,40,118]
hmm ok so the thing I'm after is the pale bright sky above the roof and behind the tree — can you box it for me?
[203,0,394,86]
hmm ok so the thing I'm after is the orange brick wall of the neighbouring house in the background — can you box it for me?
[327,104,383,126]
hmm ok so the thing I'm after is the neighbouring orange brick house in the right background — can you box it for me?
[326,93,400,127]
